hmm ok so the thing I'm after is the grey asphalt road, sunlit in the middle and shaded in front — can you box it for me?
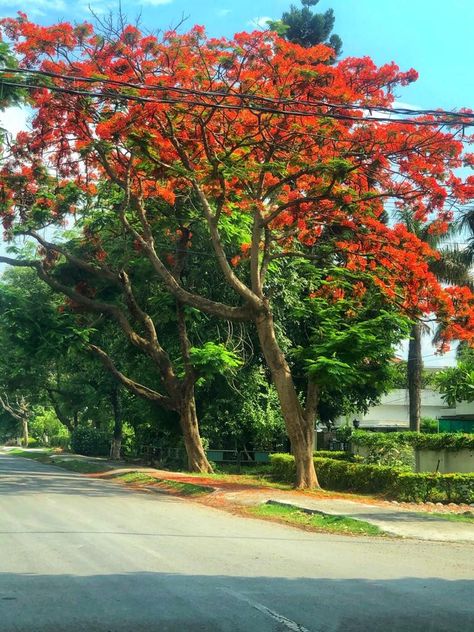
[0,455,474,632]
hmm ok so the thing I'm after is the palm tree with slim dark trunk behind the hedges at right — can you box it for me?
[404,220,474,432]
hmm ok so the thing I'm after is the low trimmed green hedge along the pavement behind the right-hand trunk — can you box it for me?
[270,454,474,503]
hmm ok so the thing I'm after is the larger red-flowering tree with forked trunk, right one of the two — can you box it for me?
[2,15,474,487]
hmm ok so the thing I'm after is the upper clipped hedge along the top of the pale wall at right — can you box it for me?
[351,430,474,451]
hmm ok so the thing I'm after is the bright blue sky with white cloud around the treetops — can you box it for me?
[0,0,474,366]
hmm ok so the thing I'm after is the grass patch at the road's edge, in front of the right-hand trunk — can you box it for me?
[249,504,385,536]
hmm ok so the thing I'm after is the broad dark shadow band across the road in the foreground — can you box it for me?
[0,572,474,632]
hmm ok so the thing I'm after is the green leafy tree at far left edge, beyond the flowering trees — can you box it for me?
[0,269,131,450]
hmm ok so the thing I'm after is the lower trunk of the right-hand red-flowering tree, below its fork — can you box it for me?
[256,311,319,489]
